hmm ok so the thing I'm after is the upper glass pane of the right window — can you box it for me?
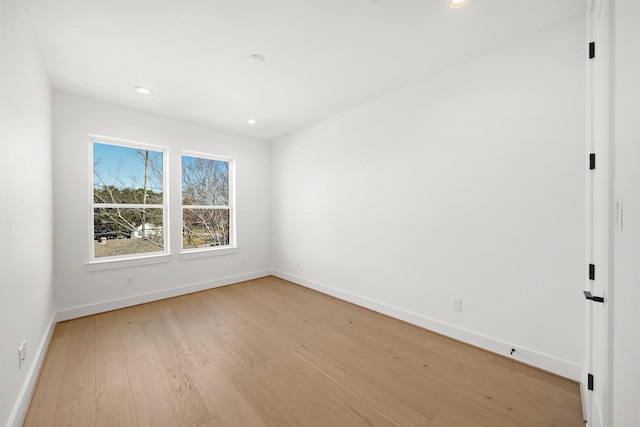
[182,156,229,206]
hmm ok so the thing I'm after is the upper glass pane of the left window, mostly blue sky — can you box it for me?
[93,142,162,205]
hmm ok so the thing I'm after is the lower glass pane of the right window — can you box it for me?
[182,208,229,249]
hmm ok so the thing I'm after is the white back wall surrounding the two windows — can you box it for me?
[53,92,271,319]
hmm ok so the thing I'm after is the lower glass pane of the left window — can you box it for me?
[93,208,164,258]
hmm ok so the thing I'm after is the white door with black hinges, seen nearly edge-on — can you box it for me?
[583,0,614,427]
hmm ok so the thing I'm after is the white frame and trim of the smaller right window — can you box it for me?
[179,150,238,259]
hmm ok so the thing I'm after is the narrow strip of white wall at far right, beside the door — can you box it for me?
[612,0,640,426]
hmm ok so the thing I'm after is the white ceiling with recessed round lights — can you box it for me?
[24,0,586,140]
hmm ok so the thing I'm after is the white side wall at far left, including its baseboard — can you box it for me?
[0,0,53,425]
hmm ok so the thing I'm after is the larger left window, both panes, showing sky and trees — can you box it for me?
[91,138,168,259]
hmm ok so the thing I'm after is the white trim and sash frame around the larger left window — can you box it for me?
[86,134,172,271]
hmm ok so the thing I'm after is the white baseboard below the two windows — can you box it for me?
[55,270,271,322]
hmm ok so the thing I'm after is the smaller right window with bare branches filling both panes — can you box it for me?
[182,152,235,250]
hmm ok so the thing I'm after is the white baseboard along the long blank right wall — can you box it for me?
[271,270,582,382]
